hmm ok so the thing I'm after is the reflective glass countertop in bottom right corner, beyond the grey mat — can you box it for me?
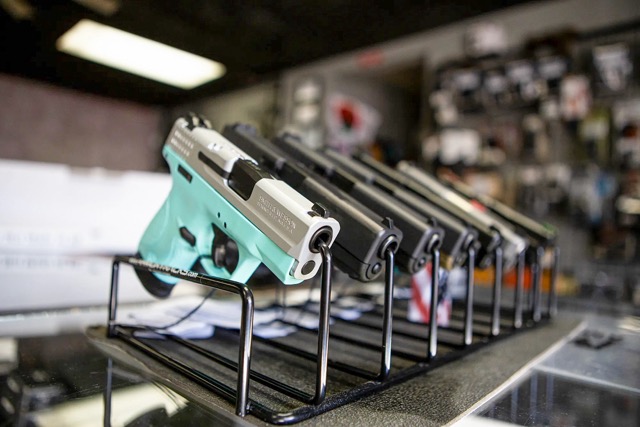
[476,316,640,427]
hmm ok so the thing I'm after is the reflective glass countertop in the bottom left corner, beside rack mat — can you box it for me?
[0,334,246,427]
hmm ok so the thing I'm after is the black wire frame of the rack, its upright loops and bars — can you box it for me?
[107,244,559,424]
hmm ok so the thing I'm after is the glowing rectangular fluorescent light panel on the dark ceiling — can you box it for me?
[56,19,225,89]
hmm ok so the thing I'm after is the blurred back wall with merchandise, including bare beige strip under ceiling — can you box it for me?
[282,0,640,312]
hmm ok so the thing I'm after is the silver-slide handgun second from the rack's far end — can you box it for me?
[396,161,529,269]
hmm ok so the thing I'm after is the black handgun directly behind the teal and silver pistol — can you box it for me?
[222,124,402,282]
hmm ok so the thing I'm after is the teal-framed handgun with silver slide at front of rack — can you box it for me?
[136,116,340,298]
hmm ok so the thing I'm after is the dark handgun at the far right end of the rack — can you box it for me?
[441,175,558,247]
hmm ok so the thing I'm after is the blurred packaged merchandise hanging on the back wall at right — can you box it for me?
[422,20,640,308]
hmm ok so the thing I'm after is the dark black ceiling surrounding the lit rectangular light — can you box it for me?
[0,0,536,106]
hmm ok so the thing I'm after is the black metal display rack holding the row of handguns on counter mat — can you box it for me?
[107,244,559,424]
